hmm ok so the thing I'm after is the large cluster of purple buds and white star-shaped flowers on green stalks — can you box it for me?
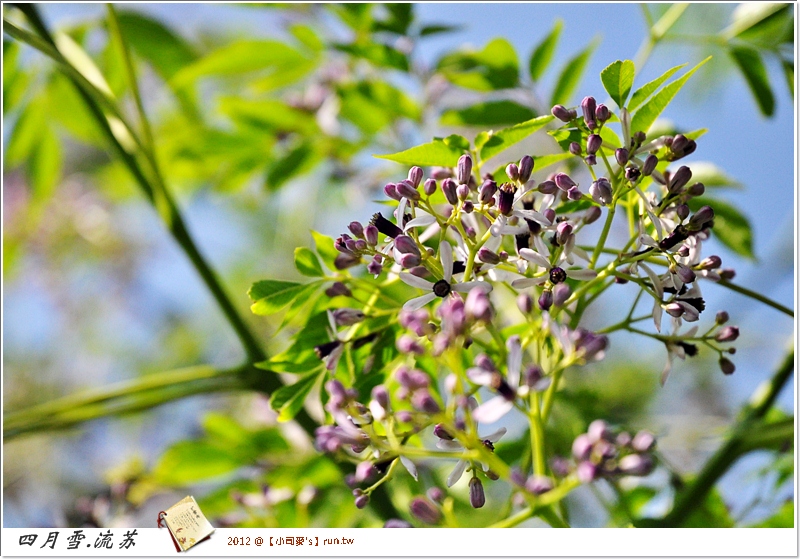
[304,89,739,526]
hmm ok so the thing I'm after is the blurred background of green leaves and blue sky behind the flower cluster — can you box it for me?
[3,4,795,527]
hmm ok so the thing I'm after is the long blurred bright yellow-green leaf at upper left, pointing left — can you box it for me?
[170,40,308,88]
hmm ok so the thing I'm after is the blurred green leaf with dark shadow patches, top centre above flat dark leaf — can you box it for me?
[436,38,519,91]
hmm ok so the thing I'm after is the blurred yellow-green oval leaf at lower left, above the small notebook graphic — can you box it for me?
[153,441,243,486]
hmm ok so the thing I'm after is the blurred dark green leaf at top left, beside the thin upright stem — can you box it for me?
[117,11,197,81]
